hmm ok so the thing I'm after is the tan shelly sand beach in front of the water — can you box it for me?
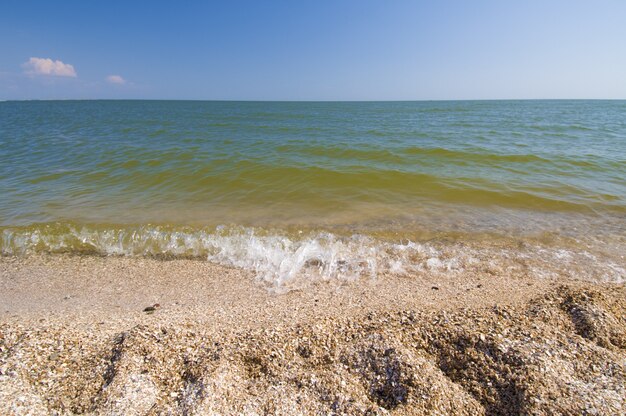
[0,255,626,415]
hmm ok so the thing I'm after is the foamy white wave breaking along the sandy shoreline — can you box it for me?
[0,223,626,288]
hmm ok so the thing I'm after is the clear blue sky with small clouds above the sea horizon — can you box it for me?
[0,0,626,100]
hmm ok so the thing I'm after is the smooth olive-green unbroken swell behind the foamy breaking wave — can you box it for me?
[64,158,626,212]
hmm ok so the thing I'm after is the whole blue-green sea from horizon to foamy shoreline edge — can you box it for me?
[0,100,626,285]
